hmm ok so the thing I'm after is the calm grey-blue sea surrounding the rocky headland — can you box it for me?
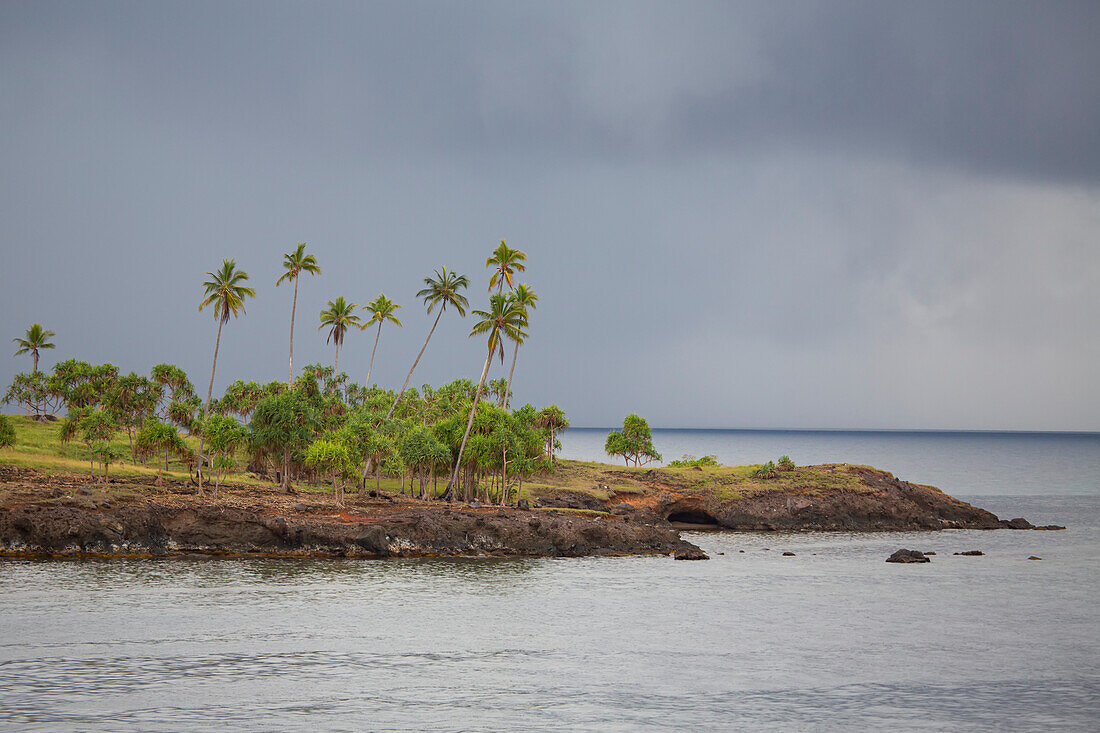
[0,429,1100,731]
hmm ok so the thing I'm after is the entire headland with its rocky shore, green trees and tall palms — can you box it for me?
[0,240,1056,559]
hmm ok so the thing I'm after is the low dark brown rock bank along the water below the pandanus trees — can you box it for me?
[0,502,697,558]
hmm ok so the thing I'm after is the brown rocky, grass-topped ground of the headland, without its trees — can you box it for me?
[0,461,1047,559]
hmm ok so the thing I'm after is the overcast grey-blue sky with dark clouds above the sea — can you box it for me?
[0,0,1100,430]
